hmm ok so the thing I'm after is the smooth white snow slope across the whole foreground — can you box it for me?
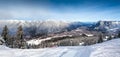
[0,39,120,57]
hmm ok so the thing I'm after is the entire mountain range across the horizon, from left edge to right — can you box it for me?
[0,20,120,36]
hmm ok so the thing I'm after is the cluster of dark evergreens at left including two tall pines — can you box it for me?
[1,25,26,48]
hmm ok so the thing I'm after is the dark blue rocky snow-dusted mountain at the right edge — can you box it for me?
[93,21,120,32]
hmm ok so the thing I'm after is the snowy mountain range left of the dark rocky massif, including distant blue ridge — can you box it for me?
[0,20,91,36]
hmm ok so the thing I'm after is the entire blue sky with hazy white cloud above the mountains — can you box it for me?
[0,0,120,21]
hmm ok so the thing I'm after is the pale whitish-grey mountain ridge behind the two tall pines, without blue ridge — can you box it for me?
[0,20,69,34]
